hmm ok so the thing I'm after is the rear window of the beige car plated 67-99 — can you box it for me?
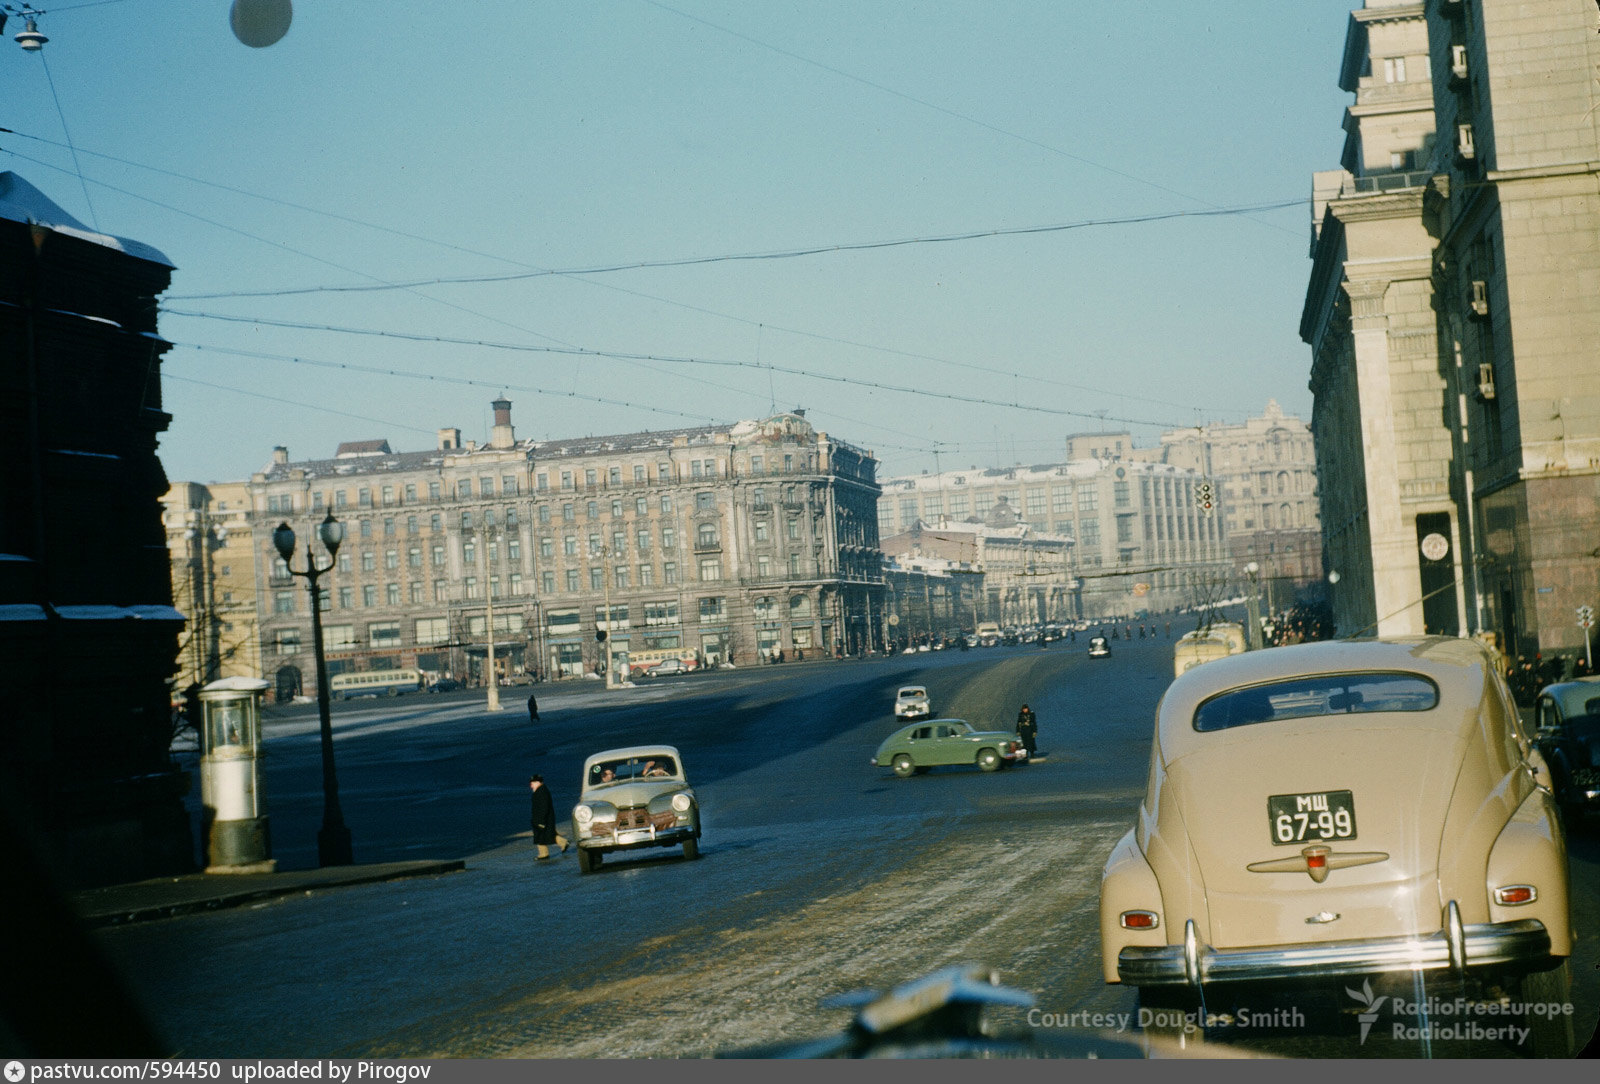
[1195,673,1438,731]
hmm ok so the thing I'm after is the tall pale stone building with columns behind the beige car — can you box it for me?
[1301,0,1600,656]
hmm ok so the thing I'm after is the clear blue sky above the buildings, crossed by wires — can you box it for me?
[0,0,1358,481]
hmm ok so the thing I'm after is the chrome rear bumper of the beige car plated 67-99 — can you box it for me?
[1117,900,1550,986]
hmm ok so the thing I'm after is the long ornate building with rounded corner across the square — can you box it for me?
[248,400,883,695]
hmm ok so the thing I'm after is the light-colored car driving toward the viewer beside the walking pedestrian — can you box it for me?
[573,745,701,873]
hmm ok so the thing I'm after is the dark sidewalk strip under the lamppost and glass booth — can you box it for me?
[70,859,467,926]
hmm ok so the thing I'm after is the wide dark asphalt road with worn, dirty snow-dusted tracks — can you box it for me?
[101,640,1600,1057]
